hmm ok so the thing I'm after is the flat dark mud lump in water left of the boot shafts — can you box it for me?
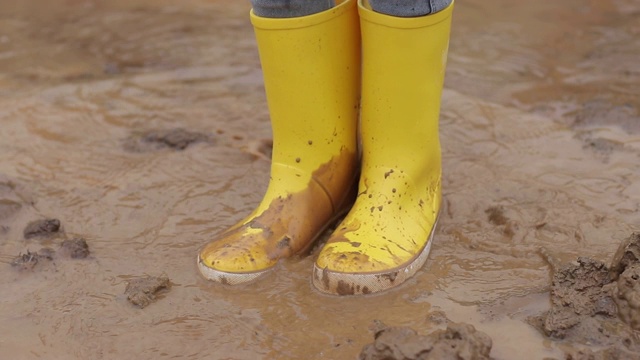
[122,128,213,153]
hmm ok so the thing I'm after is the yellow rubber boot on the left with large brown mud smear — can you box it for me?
[197,0,360,284]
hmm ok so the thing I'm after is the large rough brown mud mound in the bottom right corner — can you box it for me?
[528,233,640,360]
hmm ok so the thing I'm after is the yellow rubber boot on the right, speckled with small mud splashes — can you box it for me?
[313,0,453,295]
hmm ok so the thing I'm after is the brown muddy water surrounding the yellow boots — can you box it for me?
[0,0,640,359]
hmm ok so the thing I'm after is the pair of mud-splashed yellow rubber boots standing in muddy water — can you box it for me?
[198,0,453,295]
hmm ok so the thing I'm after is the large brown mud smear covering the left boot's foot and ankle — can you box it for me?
[200,150,357,280]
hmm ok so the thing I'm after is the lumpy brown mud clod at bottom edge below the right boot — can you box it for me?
[359,323,492,360]
